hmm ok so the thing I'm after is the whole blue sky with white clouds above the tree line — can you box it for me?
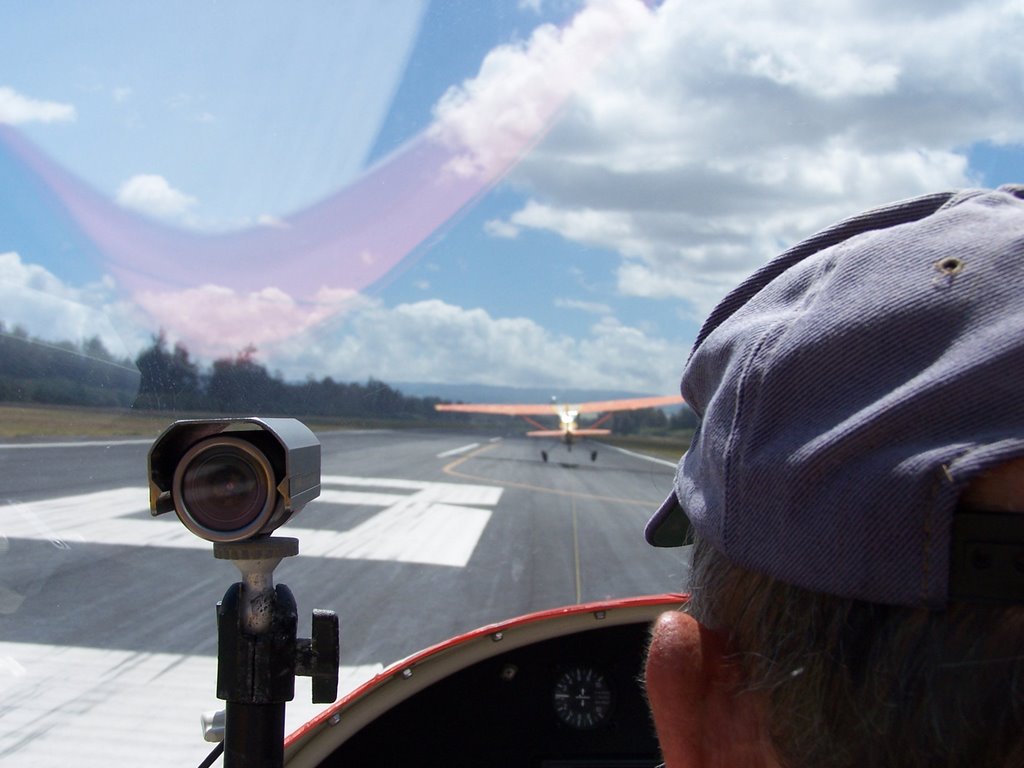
[0,0,1024,393]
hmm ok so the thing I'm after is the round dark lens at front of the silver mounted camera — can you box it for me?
[173,437,276,542]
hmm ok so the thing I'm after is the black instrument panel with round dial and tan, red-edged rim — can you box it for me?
[289,596,679,768]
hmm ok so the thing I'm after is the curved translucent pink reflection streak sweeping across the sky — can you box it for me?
[0,0,645,354]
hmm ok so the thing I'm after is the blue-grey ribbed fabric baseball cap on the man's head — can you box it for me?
[645,184,1024,607]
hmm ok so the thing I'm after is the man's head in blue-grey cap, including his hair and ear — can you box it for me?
[646,186,1024,768]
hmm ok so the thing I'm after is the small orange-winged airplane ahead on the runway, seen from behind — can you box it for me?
[434,394,683,461]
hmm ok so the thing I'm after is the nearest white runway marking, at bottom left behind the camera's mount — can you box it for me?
[0,642,383,768]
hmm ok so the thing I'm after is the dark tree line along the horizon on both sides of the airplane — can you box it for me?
[0,322,688,434]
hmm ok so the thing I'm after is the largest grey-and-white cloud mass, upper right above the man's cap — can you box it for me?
[464,0,1024,316]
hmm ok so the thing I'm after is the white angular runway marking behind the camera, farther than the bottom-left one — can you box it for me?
[0,475,502,567]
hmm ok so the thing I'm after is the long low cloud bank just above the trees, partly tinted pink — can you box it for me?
[0,253,686,392]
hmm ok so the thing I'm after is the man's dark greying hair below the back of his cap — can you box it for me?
[686,540,1024,768]
